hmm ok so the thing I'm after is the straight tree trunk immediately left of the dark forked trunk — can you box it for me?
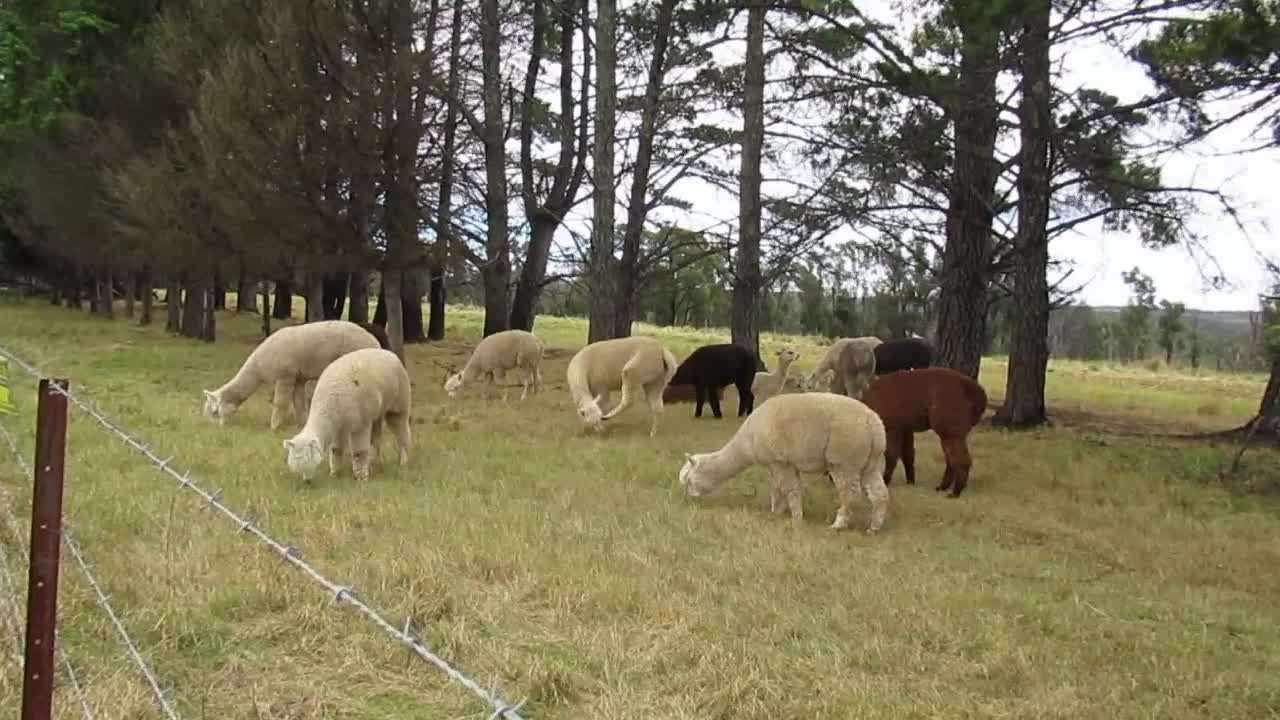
[480,0,511,337]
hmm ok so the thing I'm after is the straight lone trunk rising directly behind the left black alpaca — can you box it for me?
[730,3,764,357]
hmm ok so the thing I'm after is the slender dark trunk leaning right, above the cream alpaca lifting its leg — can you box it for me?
[613,0,675,337]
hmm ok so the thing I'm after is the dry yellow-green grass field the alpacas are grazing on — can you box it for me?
[0,295,1280,720]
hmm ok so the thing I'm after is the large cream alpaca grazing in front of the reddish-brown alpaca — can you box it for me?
[680,393,888,533]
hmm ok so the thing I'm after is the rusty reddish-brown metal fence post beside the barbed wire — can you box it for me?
[22,378,68,720]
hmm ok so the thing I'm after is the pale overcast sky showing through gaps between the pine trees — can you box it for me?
[552,0,1280,310]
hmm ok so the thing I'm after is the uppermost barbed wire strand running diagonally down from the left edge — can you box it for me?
[0,347,526,720]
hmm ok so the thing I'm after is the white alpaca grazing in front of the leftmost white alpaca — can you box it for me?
[284,347,413,480]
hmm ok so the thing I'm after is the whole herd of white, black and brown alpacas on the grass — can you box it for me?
[204,320,987,533]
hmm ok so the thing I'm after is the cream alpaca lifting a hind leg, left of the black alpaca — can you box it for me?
[566,336,677,437]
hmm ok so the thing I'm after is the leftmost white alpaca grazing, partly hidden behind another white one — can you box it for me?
[205,320,379,430]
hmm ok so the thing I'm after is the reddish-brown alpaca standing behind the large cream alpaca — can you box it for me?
[861,368,987,497]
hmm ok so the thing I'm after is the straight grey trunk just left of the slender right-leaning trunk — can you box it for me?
[588,0,618,342]
